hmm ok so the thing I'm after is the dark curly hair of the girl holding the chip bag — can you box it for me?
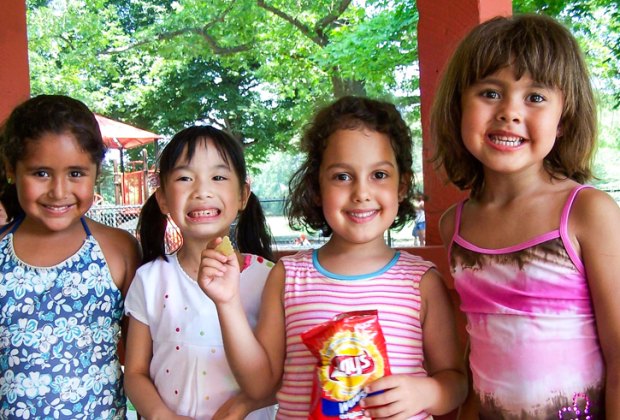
[285,96,415,236]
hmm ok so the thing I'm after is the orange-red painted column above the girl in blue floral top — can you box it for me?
[0,0,30,121]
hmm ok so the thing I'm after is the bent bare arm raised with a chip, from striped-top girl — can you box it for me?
[198,249,285,399]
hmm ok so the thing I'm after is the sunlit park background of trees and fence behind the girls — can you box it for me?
[21,0,620,246]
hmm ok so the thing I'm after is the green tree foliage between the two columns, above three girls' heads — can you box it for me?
[28,0,417,166]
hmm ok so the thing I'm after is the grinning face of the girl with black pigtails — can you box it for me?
[157,139,249,242]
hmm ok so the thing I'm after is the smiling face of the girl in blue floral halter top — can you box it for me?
[7,132,97,231]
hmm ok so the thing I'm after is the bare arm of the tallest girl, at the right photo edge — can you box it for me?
[569,190,620,419]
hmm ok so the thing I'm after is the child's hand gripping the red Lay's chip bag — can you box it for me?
[360,375,434,420]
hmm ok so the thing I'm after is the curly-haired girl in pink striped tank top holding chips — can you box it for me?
[199,97,467,419]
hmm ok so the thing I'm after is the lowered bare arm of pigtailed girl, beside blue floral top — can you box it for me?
[125,316,186,420]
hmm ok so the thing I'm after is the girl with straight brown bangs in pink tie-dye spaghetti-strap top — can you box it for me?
[431,15,620,419]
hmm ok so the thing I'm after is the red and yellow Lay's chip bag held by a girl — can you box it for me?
[301,310,390,419]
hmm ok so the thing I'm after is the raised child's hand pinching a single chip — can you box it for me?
[196,238,239,303]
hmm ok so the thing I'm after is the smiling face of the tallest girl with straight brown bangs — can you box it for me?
[461,67,563,179]
